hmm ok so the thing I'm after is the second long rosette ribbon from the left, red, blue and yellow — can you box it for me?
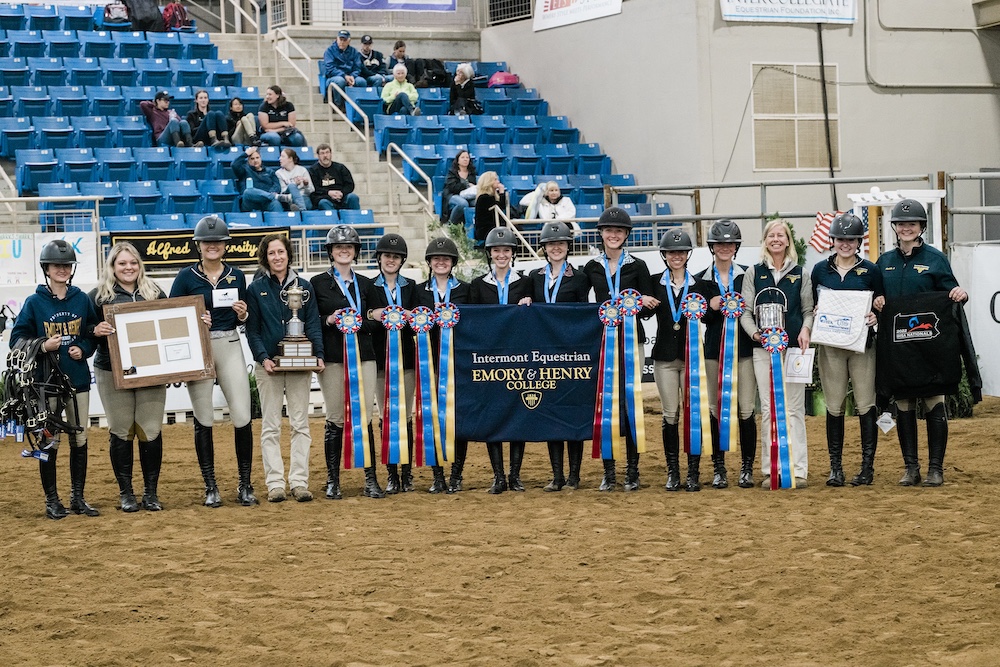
[382,306,410,465]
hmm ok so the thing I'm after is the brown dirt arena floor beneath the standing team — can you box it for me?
[0,399,1000,667]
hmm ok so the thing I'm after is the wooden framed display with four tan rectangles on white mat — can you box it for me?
[104,296,215,389]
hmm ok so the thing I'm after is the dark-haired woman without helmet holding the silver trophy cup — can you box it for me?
[246,233,324,503]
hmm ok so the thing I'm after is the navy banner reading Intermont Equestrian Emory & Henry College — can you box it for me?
[454,303,602,442]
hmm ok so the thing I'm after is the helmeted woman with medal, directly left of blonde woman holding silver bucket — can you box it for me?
[694,220,757,489]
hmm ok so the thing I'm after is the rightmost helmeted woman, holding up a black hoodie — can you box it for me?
[873,199,974,486]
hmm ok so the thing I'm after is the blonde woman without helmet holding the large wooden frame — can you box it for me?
[90,241,167,512]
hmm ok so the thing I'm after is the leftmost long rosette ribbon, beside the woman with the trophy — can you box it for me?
[333,308,375,470]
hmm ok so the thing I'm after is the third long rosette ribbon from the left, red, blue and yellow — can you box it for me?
[409,306,444,466]
